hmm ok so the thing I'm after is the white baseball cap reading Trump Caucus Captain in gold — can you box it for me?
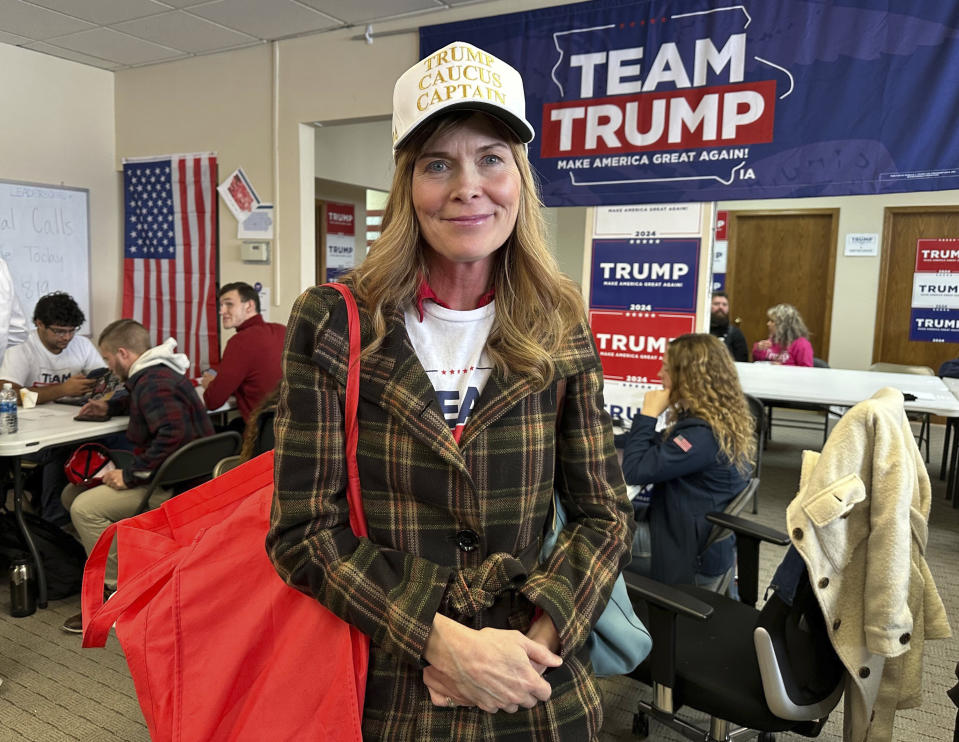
[393,41,534,155]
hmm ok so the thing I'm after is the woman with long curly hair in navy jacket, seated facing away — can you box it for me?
[623,334,756,587]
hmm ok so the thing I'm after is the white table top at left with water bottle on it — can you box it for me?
[0,402,130,456]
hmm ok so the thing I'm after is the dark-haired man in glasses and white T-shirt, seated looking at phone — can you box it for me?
[0,291,109,525]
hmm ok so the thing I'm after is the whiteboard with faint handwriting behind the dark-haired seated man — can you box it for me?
[0,180,90,333]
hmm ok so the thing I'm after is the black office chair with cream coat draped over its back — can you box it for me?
[624,514,845,742]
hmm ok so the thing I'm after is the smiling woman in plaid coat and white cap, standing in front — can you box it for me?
[267,43,633,742]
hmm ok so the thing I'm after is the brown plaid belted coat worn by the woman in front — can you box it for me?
[267,287,634,742]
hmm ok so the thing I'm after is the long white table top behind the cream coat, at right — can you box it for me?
[736,363,959,417]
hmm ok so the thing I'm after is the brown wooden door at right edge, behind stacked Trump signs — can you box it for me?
[872,206,959,371]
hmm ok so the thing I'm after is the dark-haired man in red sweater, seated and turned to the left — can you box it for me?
[200,282,286,421]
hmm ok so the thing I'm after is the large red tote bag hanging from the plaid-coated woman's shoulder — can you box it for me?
[82,286,369,742]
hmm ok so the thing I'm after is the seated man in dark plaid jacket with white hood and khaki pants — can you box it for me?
[61,319,213,633]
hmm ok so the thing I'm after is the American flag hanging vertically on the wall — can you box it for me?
[123,153,220,377]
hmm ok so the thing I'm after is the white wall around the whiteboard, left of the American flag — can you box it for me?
[0,44,121,336]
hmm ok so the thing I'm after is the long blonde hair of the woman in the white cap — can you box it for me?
[350,110,585,388]
